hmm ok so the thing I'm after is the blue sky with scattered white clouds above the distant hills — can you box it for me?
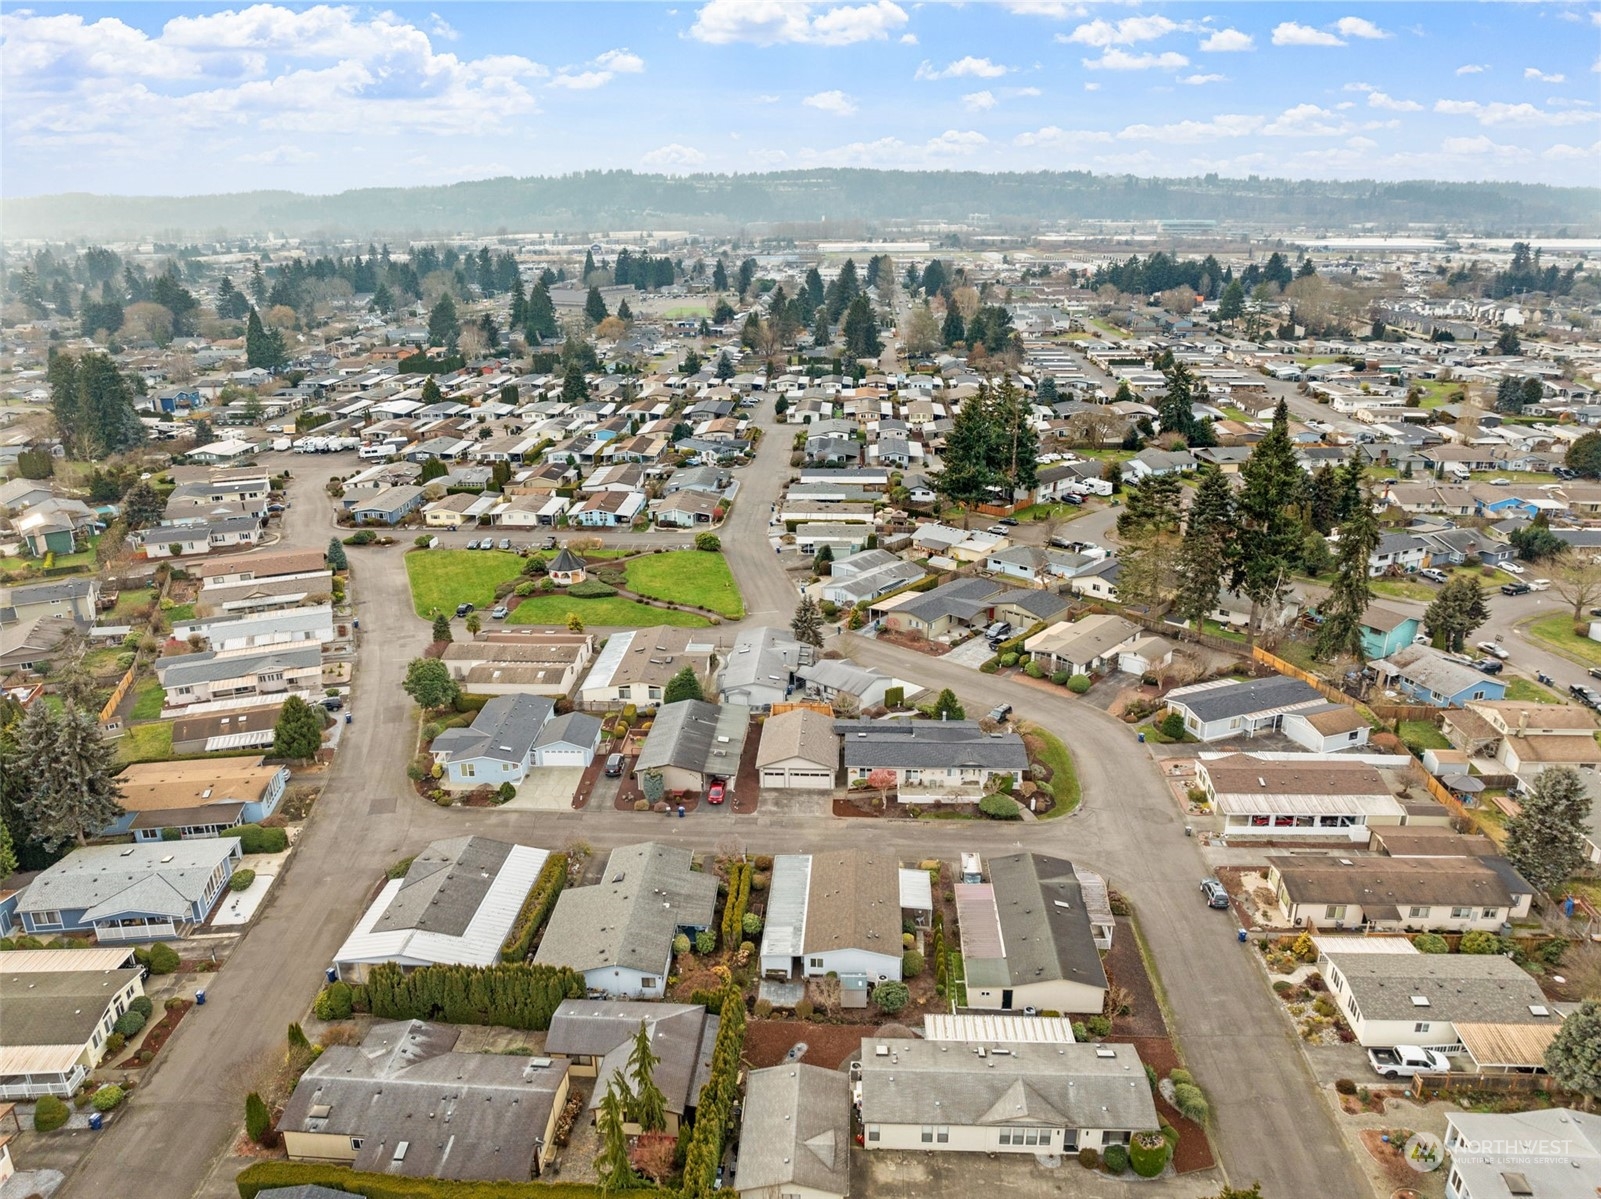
[0,0,1601,195]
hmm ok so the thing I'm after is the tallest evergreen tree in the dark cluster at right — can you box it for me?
[1230,401,1305,637]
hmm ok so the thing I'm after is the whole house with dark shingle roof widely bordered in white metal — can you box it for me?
[333,837,549,983]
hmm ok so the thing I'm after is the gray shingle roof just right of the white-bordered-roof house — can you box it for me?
[533,840,717,973]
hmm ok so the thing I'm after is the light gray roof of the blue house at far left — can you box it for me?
[18,837,239,920]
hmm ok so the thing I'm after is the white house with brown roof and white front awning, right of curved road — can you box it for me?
[1196,754,1406,844]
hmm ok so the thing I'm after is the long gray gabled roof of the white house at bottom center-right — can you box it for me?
[861,1037,1156,1132]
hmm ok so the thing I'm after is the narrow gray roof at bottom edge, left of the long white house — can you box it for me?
[736,1063,850,1194]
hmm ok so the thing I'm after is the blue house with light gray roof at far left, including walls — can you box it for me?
[16,837,243,944]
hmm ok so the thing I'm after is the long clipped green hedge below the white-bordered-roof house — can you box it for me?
[367,962,584,1033]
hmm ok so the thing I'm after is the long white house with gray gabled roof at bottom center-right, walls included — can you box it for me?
[852,1037,1158,1156]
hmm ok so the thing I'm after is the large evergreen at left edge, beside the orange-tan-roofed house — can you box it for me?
[6,701,123,850]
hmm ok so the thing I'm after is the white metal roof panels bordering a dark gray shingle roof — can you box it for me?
[333,845,551,965]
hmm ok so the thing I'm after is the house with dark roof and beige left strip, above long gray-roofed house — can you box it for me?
[956,853,1108,1015]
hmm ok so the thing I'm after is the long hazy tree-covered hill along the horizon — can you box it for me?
[0,170,1601,240]
